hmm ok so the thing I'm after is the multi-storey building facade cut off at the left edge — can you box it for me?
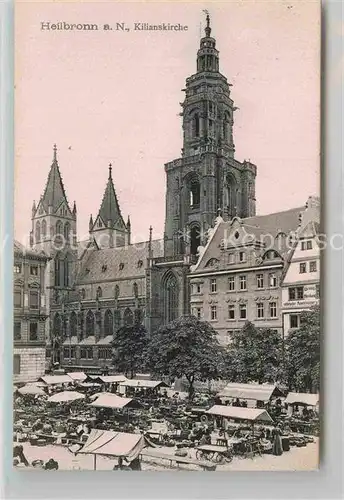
[13,241,48,382]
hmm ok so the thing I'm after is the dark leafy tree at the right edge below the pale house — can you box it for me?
[285,306,320,392]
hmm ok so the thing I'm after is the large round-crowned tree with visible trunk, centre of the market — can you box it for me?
[148,316,223,399]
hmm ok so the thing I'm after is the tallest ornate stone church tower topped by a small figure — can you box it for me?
[165,15,257,256]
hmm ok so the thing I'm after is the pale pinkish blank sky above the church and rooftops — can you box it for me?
[15,0,320,242]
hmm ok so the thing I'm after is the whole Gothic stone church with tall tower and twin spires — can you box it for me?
[31,16,257,368]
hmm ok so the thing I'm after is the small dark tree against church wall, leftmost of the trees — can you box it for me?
[112,325,148,378]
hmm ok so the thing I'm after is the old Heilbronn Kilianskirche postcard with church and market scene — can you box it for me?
[13,0,325,472]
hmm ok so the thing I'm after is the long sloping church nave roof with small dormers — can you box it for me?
[76,240,164,285]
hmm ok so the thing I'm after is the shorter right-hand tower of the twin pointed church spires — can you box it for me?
[89,163,131,248]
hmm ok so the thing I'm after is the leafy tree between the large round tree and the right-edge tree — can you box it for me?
[225,322,283,384]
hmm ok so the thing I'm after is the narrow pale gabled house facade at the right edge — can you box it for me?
[281,198,320,336]
